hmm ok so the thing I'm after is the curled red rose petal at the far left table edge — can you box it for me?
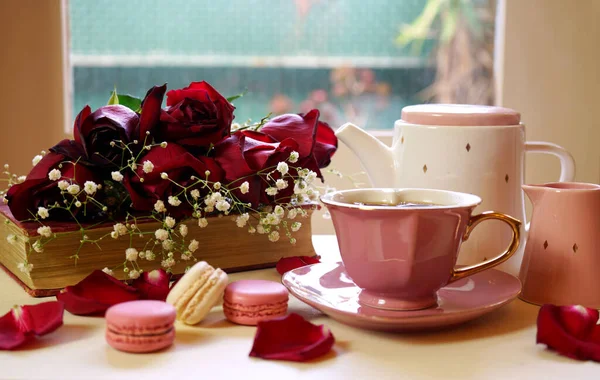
[0,301,64,350]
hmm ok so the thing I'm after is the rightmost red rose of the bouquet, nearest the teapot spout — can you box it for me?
[260,109,338,168]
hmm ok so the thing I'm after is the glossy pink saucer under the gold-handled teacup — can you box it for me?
[282,263,521,331]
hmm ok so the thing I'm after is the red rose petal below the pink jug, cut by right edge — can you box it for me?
[536,305,600,361]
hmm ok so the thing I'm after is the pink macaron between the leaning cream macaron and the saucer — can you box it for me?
[223,280,289,326]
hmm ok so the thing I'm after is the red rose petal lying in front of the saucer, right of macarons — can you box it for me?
[250,313,335,362]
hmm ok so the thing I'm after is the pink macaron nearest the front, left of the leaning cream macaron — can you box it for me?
[106,300,176,352]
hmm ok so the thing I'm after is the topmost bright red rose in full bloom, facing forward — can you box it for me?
[151,82,235,151]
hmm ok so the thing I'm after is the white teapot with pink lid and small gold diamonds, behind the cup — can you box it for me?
[336,104,575,275]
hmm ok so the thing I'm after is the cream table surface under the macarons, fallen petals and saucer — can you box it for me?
[0,235,600,380]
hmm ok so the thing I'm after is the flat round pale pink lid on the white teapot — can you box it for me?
[402,104,521,126]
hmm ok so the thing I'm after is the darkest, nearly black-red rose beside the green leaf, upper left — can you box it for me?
[71,105,143,167]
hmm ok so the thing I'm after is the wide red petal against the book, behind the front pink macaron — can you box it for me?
[56,270,141,315]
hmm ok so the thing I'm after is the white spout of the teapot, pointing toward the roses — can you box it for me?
[335,123,395,187]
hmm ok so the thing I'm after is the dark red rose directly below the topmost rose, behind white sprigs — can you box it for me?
[124,143,223,216]
